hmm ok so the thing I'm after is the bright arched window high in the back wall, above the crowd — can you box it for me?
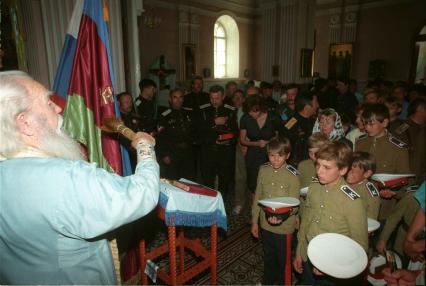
[214,15,240,78]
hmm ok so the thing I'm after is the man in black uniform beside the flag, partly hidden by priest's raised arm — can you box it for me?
[117,92,141,172]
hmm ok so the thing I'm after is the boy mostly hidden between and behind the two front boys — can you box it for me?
[297,132,329,188]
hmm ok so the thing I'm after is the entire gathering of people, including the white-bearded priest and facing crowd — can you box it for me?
[0,68,426,285]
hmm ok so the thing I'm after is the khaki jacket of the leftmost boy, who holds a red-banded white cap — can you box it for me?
[251,163,300,234]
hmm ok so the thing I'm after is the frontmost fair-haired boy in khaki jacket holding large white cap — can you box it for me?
[293,141,368,285]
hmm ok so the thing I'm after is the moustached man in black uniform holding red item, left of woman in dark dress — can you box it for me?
[199,85,238,198]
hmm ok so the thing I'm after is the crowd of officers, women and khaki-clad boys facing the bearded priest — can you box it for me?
[119,77,426,284]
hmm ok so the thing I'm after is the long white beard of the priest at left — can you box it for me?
[37,115,84,160]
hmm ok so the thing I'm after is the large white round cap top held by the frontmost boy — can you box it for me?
[308,233,368,279]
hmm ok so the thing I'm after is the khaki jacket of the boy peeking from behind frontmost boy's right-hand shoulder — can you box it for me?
[350,180,381,220]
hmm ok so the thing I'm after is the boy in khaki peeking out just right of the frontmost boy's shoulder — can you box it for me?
[346,152,380,220]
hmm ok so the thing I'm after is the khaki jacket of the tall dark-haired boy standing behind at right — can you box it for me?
[355,131,411,220]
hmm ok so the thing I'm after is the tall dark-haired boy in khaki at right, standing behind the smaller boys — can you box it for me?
[355,104,410,220]
